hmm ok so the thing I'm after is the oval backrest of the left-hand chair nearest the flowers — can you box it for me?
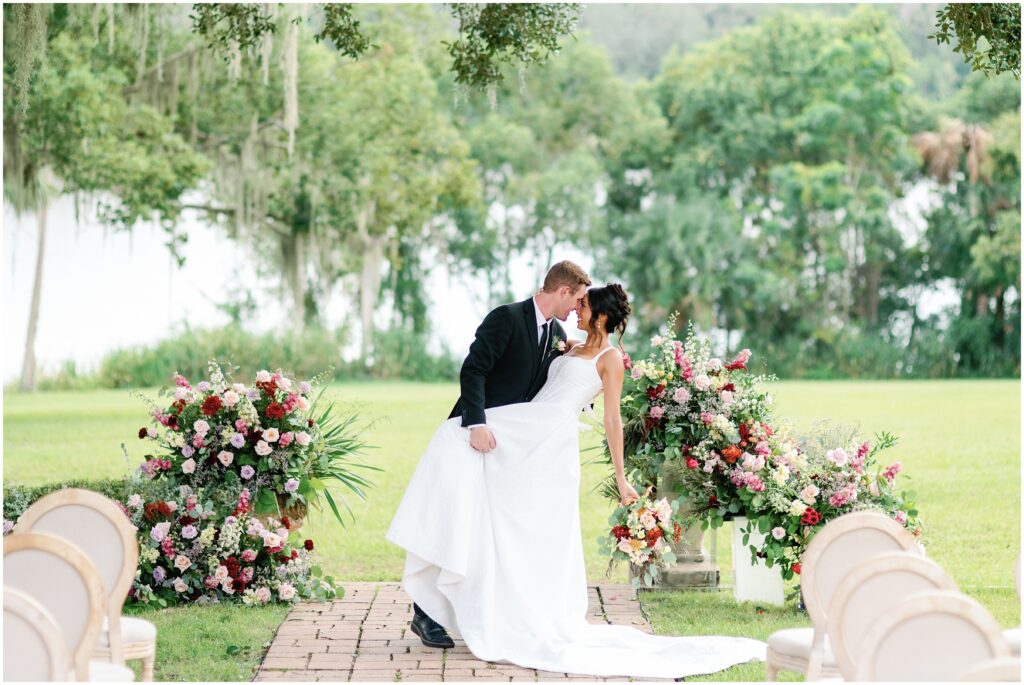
[16,488,138,620]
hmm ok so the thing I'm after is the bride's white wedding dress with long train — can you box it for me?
[386,347,766,678]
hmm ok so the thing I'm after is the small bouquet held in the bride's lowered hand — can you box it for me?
[598,488,683,589]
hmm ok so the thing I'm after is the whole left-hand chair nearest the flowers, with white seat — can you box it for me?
[17,488,157,681]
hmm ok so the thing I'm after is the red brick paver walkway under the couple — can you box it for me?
[256,583,671,682]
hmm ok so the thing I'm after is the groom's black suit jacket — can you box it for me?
[449,298,566,426]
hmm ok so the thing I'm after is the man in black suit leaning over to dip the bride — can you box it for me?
[410,255,590,648]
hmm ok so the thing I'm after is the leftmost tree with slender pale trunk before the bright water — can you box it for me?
[4,5,206,390]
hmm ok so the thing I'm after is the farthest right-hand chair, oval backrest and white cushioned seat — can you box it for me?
[766,511,922,681]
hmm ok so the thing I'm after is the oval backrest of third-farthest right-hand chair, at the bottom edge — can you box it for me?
[855,591,1011,682]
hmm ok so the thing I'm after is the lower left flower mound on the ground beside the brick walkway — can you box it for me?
[123,485,337,606]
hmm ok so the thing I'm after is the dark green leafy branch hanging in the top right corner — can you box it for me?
[929,2,1021,80]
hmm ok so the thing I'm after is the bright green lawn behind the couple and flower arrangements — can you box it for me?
[3,381,1021,680]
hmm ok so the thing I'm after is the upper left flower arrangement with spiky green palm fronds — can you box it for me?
[138,362,380,524]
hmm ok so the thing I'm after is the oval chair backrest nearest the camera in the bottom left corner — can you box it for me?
[3,587,71,683]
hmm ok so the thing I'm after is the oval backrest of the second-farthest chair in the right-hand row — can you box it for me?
[826,552,957,680]
